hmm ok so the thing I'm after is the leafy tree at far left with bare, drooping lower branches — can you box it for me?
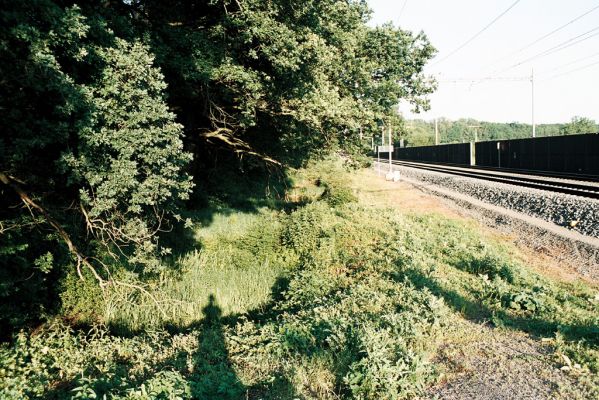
[0,0,191,332]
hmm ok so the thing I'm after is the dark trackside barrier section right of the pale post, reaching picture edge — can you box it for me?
[475,134,599,175]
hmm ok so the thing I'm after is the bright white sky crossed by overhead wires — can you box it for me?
[368,0,599,124]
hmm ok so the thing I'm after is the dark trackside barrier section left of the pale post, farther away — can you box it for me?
[393,143,471,165]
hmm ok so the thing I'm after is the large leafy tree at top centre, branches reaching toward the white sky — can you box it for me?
[124,0,434,162]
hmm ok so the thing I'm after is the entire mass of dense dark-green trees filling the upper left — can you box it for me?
[0,0,434,333]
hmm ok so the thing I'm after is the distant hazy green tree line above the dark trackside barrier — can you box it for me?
[402,117,599,146]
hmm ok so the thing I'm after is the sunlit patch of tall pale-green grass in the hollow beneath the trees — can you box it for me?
[103,209,288,332]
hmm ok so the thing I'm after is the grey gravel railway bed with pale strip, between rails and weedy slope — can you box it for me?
[376,162,599,279]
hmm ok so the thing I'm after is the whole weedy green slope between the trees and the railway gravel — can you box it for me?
[0,161,599,399]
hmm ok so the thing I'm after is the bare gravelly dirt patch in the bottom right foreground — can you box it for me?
[424,322,592,400]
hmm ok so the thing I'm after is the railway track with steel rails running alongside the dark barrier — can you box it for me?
[393,161,599,199]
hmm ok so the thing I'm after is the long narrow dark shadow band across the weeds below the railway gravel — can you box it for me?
[392,269,599,345]
